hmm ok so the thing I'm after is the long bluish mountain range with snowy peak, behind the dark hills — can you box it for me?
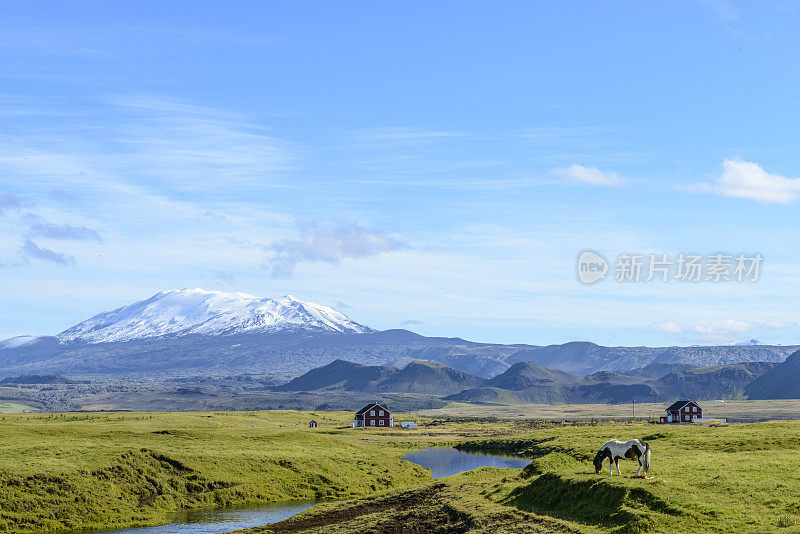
[0,288,800,387]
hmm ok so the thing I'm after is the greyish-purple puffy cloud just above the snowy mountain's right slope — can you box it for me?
[261,223,406,277]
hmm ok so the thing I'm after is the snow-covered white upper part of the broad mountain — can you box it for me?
[57,288,372,343]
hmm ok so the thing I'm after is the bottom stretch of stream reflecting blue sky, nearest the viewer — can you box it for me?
[93,501,317,534]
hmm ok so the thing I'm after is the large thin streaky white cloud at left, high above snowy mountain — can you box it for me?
[0,94,294,200]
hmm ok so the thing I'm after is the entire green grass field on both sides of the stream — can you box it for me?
[0,411,800,533]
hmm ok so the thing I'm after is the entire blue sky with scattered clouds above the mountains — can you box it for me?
[0,1,800,345]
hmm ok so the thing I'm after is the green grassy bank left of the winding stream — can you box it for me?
[0,412,440,532]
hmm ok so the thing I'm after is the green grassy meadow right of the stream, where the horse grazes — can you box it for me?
[242,422,800,534]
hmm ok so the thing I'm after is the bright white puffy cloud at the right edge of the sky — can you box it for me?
[711,160,800,204]
